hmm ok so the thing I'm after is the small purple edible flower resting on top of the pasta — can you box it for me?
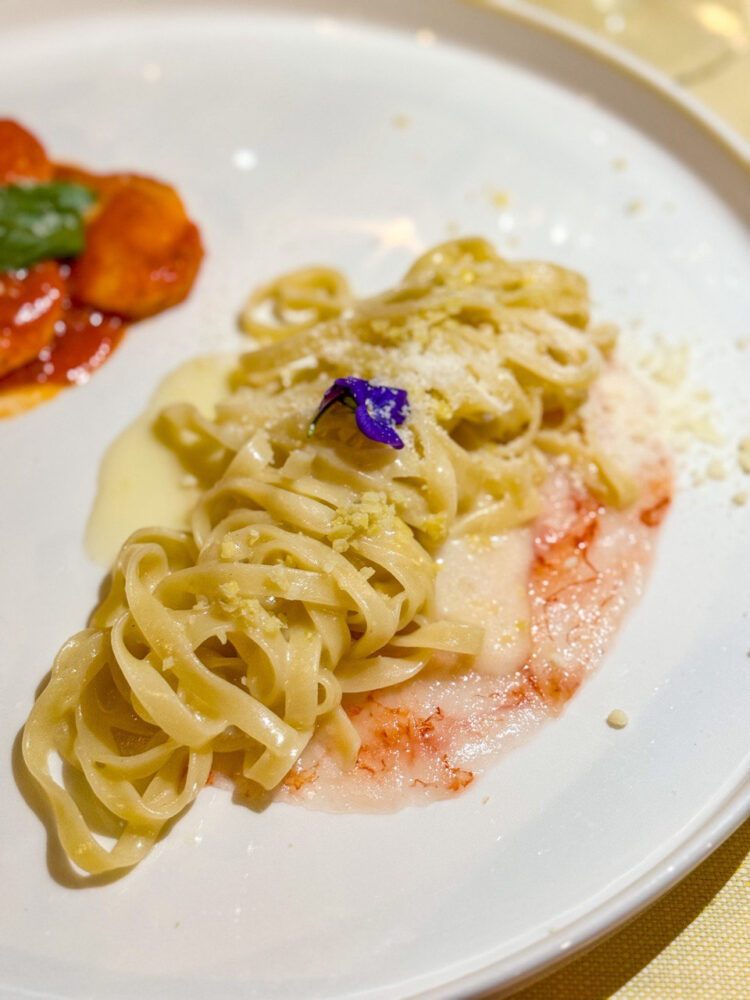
[307,375,409,448]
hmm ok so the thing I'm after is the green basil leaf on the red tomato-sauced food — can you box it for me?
[0,181,96,271]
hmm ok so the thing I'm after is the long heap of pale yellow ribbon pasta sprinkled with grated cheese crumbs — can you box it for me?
[23,239,636,873]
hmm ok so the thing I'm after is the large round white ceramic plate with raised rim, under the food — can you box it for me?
[0,0,750,1000]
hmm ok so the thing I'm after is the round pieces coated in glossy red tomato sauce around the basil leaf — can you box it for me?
[0,119,203,416]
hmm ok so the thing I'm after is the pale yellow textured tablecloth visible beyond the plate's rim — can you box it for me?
[494,0,750,1000]
